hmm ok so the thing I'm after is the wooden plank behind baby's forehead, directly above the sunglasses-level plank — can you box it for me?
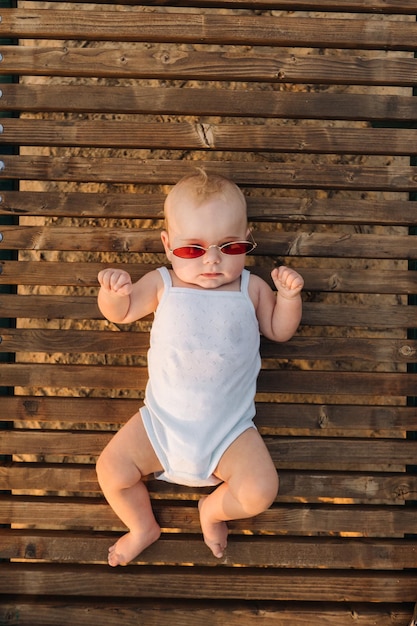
[0,193,417,226]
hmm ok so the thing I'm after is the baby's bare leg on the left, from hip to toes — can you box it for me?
[97,413,162,567]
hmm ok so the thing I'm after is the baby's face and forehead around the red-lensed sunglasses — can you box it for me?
[162,194,248,289]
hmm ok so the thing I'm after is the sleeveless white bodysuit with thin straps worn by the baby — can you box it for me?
[141,267,261,486]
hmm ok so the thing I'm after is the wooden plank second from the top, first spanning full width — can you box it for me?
[2,8,417,51]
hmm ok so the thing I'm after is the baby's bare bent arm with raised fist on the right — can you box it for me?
[251,265,304,341]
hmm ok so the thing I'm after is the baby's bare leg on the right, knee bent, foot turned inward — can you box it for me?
[199,428,278,558]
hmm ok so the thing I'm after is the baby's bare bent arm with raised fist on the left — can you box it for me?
[98,269,163,324]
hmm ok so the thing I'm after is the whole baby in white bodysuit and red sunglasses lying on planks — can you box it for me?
[97,170,303,566]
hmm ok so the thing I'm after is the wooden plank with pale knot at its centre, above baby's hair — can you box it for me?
[4,118,417,156]
